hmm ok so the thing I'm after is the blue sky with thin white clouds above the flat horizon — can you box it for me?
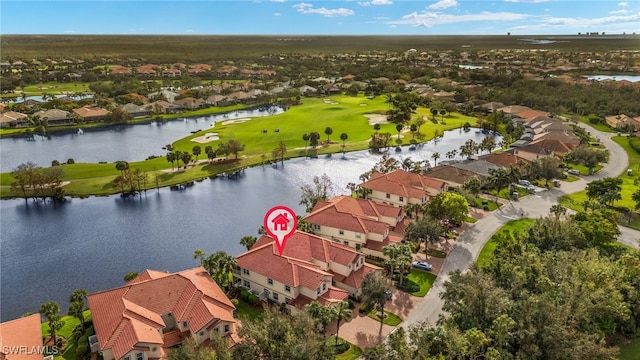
[0,0,640,35]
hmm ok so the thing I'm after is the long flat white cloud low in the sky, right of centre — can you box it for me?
[389,11,530,27]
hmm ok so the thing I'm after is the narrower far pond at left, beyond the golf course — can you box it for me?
[0,106,284,172]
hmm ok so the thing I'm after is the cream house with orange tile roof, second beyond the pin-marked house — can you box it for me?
[358,170,447,206]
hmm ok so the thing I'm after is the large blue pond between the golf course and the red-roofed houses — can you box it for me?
[0,130,500,320]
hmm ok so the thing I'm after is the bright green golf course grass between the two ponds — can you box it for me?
[0,95,476,198]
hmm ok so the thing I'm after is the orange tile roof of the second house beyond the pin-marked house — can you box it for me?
[360,170,446,199]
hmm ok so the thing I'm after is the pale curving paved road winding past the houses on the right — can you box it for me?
[401,124,640,330]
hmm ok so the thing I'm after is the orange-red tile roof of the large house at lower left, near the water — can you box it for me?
[87,267,234,358]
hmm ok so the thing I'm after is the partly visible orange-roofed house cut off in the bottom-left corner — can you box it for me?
[0,314,56,360]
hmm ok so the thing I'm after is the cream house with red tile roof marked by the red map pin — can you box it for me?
[233,231,382,312]
